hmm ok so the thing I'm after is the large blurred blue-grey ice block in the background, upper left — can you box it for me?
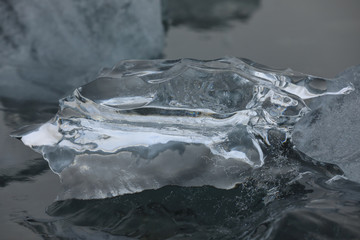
[0,0,164,102]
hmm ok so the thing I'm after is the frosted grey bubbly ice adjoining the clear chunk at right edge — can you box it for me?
[293,66,360,182]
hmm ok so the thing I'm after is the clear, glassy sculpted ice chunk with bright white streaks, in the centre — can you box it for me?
[16,57,352,198]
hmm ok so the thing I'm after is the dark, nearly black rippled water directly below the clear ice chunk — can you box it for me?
[19,146,360,239]
